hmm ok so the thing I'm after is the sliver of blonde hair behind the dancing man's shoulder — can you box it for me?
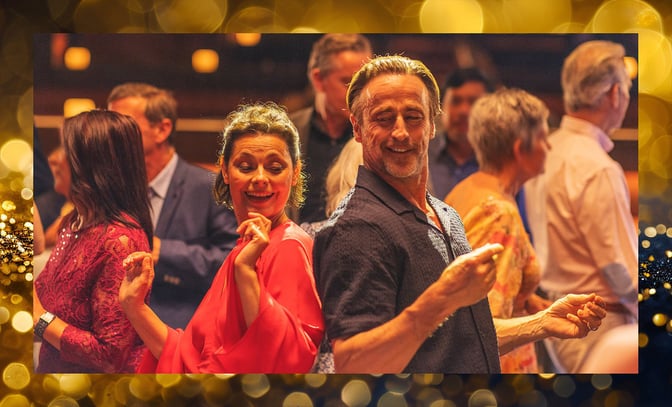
[325,138,364,218]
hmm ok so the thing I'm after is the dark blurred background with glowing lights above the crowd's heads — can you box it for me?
[33,33,638,174]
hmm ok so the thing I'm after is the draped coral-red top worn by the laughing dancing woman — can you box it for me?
[139,223,324,373]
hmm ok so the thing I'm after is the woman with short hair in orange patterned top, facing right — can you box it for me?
[445,89,550,373]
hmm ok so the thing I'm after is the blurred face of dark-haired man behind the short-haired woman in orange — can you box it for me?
[441,81,487,143]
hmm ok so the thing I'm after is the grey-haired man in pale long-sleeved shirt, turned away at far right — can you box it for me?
[525,40,637,373]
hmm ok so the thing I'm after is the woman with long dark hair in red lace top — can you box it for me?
[33,110,152,373]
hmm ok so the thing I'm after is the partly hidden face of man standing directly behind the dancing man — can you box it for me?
[313,51,371,120]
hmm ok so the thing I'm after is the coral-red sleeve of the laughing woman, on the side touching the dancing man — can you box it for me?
[208,239,324,373]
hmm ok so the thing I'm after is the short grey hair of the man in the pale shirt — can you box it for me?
[562,40,630,112]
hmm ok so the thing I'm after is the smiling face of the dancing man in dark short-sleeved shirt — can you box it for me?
[353,74,434,182]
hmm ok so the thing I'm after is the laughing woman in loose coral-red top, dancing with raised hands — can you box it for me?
[119,103,324,373]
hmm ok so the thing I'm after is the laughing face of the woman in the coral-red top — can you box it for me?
[222,134,300,227]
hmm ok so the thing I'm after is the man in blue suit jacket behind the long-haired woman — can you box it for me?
[107,83,238,328]
